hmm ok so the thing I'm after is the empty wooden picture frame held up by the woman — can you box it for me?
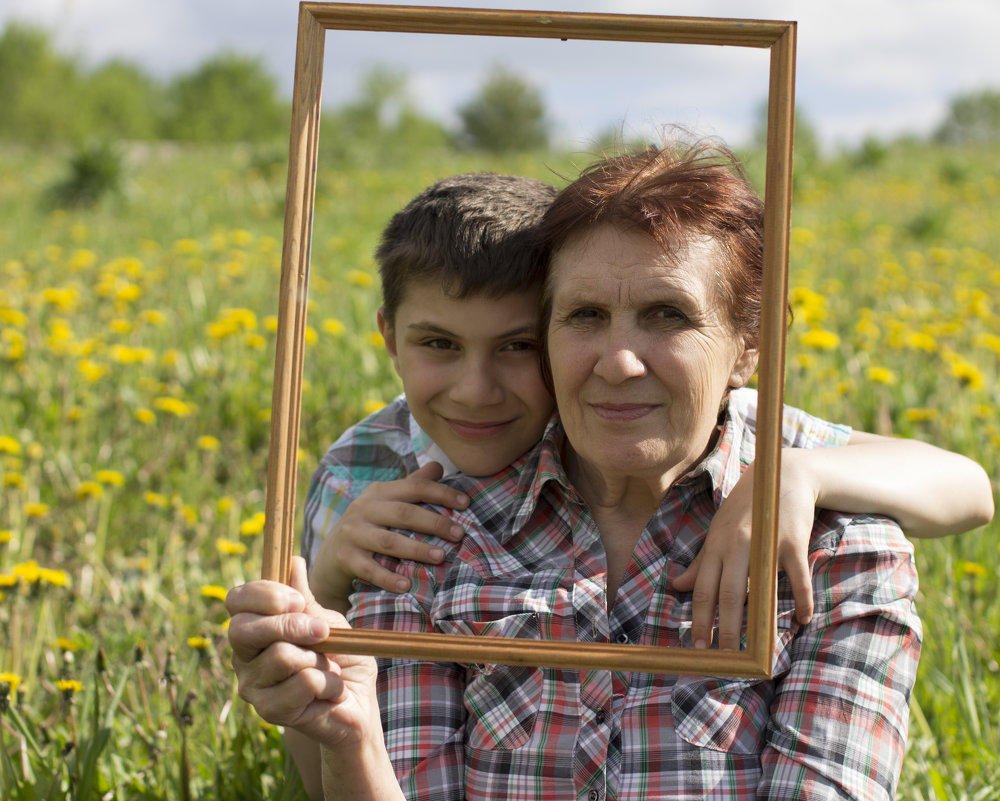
[262,2,796,678]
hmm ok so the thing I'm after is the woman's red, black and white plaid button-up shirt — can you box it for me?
[352,396,921,801]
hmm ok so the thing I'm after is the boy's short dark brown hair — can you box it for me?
[375,172,556,325]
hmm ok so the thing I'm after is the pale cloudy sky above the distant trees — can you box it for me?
[0,0,1000,145]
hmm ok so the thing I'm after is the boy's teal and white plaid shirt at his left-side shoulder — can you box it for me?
[301,395,455,566]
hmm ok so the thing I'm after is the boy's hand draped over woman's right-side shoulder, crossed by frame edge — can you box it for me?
[673,451,816,650]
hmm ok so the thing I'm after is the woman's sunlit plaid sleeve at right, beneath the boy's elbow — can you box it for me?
[757,512,922,801]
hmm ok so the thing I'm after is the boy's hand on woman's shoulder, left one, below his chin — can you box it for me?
[310,462,469,609]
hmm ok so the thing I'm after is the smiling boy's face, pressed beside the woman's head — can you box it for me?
[378,281,553,476]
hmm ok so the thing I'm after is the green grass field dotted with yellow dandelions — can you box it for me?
[0,138,1000,801]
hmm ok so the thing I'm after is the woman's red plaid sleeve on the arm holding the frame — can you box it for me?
[349,563,466,801]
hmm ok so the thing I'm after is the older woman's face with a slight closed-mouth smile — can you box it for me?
[548,225,757,489]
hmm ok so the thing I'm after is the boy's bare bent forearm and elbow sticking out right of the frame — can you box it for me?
[796,432,993,537]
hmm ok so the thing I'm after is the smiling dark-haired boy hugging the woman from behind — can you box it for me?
[287,173,992,797]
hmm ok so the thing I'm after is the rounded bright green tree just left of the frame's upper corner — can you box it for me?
[164,53,288,142]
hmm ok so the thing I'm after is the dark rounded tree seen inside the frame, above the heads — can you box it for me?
[458,67,549,153]
